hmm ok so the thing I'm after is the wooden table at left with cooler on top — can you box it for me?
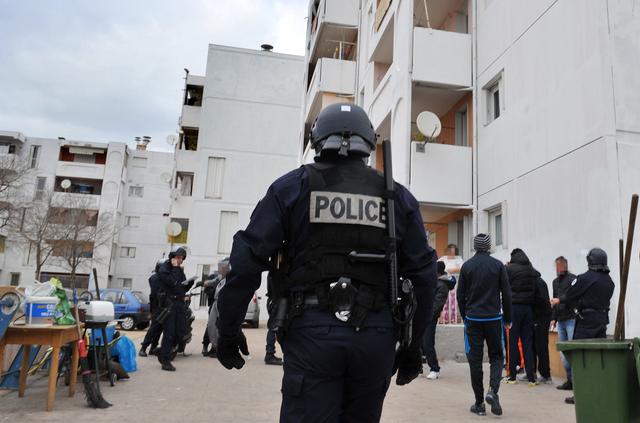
[0,325,80,411]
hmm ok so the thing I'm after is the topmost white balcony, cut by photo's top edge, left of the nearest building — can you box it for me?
[309,0,360,63]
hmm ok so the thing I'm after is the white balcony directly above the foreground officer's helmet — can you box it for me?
[305,57,356,123]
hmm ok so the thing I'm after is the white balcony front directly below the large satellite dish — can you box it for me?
[411,142,473,206]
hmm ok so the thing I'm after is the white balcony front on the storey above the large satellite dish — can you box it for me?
[412,28,471,88]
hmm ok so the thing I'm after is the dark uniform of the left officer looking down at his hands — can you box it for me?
[158,260,190,363]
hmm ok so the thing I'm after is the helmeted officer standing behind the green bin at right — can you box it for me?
[551,248,615,404]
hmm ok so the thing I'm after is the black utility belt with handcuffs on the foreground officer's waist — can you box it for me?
[268,277,389,339]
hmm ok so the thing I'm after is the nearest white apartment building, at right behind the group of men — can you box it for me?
[299,0,640,335]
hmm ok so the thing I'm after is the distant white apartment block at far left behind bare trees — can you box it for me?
[0,131,173,291]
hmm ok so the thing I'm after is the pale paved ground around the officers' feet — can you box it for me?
[0,320,575,423]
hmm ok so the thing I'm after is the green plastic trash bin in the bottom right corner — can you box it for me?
[556,338,640,423]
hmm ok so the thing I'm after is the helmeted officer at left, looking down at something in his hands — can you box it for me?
[158,247,193,371]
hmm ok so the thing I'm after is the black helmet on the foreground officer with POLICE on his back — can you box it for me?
[309,103,377,157]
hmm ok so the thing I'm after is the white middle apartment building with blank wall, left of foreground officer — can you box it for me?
[170,44,303,308]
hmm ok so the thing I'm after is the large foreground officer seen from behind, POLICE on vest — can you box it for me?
[217,104,436,422]
